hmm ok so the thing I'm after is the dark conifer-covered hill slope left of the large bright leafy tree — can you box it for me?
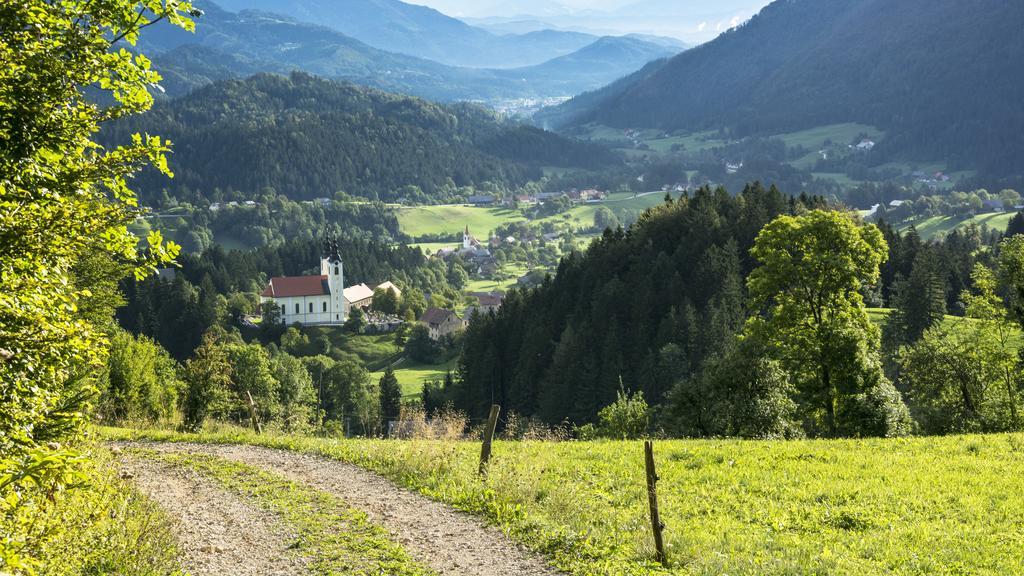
[445,184,811,423]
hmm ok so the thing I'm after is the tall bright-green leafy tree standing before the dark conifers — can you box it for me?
[746,210,908,436]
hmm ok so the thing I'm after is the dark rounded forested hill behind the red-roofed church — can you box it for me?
[103,73,616,201]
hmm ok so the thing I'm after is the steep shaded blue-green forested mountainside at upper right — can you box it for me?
[544,0,1024,173]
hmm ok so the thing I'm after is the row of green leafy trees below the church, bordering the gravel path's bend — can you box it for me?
[96,328,401,436]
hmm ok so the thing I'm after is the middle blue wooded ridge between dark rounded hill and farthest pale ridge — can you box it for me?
[139,0,678,101]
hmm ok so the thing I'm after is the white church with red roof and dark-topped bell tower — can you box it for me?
[260,251,349,326]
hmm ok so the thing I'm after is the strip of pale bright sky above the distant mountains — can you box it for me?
[404,0,770,44]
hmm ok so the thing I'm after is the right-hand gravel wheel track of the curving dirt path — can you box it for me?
[122,443,562,576]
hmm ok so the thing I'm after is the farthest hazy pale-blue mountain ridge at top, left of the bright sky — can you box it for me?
[210,0,597,68]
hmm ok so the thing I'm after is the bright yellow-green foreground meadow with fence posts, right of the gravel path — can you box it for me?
[110,430,1024,576]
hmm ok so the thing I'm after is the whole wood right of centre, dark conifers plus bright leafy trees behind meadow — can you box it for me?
[448,184,1024,437]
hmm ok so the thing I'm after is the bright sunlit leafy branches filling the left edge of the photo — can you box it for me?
[0,0,193,574]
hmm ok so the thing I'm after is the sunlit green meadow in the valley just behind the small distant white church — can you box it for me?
[398,206,526,240]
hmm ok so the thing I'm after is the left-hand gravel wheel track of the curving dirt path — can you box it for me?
[122,457,306,576]
